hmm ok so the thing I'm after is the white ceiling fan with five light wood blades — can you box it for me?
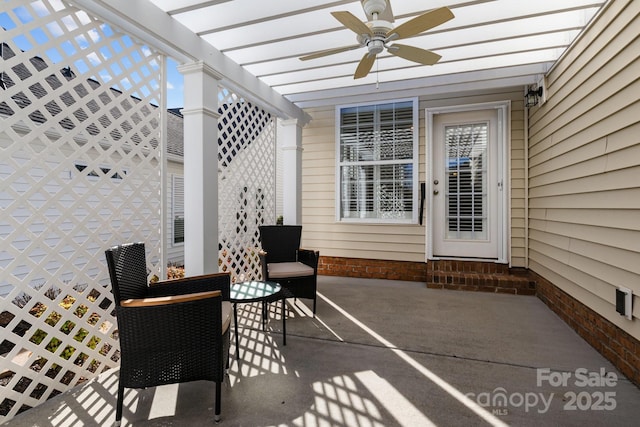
[300,0,454,79]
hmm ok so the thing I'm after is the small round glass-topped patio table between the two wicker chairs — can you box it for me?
[230,280,287,359]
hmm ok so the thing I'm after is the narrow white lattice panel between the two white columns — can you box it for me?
[218,88,276,280]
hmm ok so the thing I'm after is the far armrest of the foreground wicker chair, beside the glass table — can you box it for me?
[149,273,231,301]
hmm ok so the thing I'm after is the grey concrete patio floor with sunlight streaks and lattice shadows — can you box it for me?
[5,276,640,427]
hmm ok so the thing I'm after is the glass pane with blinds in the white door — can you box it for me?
[444,123,489,240]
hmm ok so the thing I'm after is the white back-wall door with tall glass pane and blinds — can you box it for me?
[428,108,504,261]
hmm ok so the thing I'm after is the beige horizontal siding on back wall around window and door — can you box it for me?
[302,89,526,266]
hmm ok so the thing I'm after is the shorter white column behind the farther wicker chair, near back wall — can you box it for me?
[278,119,302,225]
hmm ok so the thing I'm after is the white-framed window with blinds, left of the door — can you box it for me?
[336,99,418,223]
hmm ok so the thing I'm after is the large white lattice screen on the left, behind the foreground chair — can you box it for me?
[0,0,164,423]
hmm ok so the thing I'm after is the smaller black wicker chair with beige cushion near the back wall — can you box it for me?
[258,225,320,316]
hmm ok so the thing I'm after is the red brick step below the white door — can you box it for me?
[427,270,536,295]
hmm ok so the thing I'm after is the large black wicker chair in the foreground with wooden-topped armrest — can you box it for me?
[105,243,231,426]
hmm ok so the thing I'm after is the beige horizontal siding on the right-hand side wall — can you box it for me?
[529,0,640,339]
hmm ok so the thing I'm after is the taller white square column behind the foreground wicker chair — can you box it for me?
[178,61,222,276]
